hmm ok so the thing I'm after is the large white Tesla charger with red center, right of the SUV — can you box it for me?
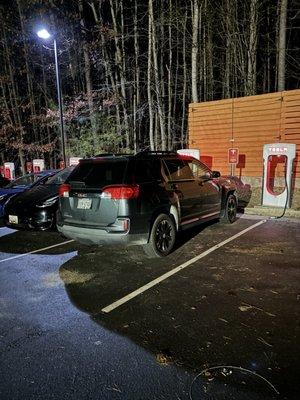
[262,143,296,207]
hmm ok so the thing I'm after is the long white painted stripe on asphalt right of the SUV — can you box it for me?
[101,219,267,313]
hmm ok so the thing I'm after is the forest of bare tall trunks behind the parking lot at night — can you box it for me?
[0,0,300,171]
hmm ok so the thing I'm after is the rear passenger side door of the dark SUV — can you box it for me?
[164,158,203,225]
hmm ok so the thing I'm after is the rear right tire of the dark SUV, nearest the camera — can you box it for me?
[144,214,176,258]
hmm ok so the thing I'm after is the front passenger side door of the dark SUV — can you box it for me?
[188,160,221,216]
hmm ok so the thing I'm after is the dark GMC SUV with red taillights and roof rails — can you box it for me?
[57,152,237,256]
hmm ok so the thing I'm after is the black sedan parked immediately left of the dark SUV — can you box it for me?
[4,167,73,230]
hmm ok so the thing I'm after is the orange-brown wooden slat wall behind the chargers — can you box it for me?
[189,89,300,178]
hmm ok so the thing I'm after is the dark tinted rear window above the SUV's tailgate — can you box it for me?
[68,160,128,188]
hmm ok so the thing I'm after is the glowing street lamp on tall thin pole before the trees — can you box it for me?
[37,28,67,167]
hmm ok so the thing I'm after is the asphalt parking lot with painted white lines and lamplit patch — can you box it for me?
[0,217,300,400]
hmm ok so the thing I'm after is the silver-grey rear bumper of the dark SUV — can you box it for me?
[57,225,148,245]
